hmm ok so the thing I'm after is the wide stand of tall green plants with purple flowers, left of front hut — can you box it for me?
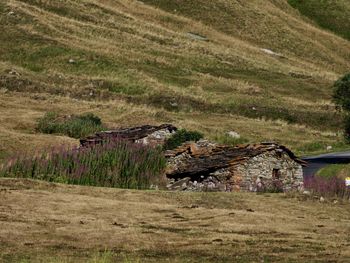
[0,140,166,189]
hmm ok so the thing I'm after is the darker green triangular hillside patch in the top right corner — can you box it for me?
[288,0,350,40]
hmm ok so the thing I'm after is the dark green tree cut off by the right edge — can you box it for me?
[333,73,350,142]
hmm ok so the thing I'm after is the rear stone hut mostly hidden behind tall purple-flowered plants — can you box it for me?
[80,124,177,147]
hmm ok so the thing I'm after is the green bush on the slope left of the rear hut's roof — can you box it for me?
[37,112,104,139]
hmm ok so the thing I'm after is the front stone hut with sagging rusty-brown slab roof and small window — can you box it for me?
[166,141,306,192]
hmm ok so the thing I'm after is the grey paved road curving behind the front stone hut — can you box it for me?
[302,151,350,177]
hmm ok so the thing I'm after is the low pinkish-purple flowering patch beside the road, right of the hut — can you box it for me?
[304,176,350,199]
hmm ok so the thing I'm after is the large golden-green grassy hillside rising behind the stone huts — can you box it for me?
[0,0,350,158]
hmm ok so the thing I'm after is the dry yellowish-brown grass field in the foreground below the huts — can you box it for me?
[0,179,350,263]
